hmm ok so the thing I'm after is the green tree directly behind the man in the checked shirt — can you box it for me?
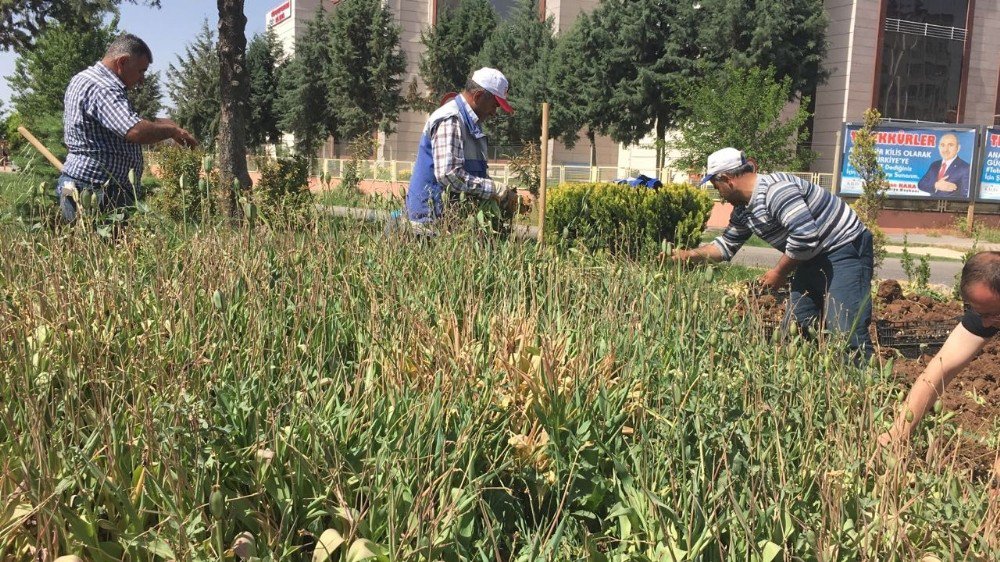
[7,15,118,162]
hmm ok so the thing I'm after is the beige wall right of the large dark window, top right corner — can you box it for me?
[962,1,1000,125]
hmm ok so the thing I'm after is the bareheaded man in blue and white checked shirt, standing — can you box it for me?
[56,33,198,222]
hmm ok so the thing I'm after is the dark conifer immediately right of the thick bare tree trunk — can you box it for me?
[246,30,284,148]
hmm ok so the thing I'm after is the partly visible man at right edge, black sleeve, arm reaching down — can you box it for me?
[878,252,1000,446]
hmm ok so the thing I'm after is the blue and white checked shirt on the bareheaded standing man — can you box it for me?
[63,62,143,189]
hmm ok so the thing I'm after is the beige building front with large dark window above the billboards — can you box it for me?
[813,0,1000,172]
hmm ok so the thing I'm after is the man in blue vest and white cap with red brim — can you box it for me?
[406,68,517,228]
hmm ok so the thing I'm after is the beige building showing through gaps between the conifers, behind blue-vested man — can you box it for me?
[265,0,618,166]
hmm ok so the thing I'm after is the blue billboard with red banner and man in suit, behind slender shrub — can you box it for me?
[840,123,976,201]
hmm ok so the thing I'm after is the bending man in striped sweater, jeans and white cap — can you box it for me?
[673,148,874,358]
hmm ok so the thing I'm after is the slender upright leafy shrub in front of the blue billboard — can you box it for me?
[849,108,889,270]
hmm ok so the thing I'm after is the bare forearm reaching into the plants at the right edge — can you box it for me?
[878,324,986,445]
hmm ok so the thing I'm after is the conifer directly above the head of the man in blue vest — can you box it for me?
[420,0,498,100]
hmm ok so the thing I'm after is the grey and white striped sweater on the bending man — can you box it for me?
[713,172,865,261]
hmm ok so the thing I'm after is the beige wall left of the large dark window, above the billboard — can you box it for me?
[812,0,880,173]
